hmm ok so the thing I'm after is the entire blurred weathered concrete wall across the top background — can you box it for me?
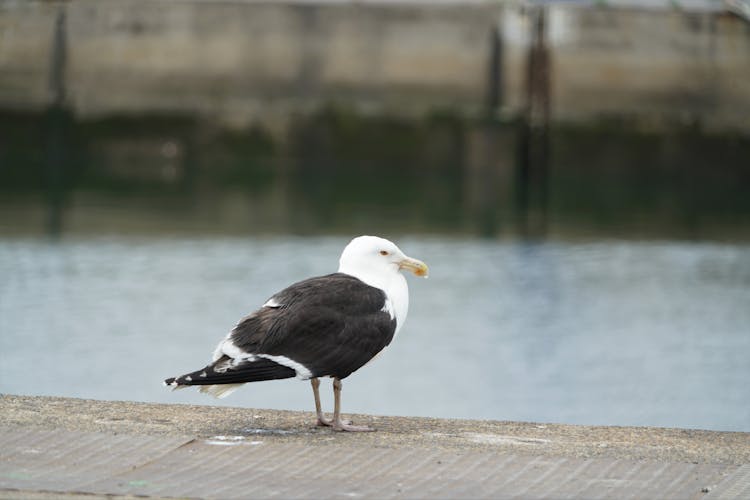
[0,0,750,131]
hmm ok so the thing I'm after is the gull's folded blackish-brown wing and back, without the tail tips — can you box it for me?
[235,273,396,378]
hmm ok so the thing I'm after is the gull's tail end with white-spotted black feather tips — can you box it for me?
[164,356,297,398]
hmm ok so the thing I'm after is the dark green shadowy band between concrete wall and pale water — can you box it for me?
[0,109,750,241]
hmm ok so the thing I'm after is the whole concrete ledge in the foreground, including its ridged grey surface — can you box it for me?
[0,395,750,498]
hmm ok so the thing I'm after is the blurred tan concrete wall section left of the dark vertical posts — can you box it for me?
[0,0,500,129]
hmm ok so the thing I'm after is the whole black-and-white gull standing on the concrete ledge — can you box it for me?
[164,236,428,431]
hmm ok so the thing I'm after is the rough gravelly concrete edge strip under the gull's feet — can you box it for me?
[0,394,750,465]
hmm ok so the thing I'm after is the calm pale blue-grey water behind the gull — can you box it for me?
[0,237,750,431]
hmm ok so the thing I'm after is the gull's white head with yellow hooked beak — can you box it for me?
[339,236,428,283]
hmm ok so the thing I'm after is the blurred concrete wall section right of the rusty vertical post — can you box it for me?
[536,6,750,130]
